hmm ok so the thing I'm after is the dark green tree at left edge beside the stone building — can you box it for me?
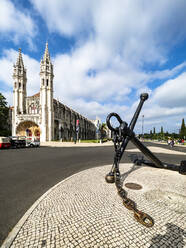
[0,93,10,136]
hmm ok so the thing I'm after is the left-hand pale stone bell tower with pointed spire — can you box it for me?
[12,49,27,135]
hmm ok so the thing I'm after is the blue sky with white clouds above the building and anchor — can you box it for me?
[0,0,186,133]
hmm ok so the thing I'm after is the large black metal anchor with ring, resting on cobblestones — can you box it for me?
[105,93,186,183]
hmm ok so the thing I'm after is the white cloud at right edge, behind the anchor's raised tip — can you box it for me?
[132,72,186,132]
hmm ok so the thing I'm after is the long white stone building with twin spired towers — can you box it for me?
[12,43,96,141]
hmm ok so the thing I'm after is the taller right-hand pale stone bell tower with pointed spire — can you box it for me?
[40,42,54,141]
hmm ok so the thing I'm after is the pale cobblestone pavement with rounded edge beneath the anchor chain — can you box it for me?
[4,164,186,248]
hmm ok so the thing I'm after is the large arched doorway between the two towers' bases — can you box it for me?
[16,121,41,139]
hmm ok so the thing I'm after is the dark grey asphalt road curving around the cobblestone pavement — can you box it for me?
[0,143,186,245]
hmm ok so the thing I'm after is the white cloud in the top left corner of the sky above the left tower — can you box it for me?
[0,0,37,48]
